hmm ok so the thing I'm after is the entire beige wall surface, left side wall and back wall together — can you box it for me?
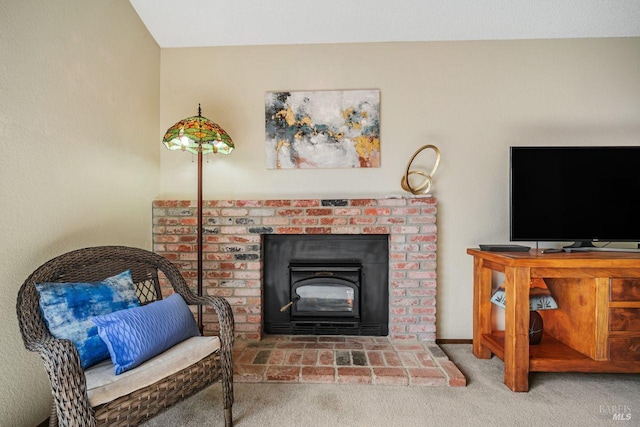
[0,0,640,426]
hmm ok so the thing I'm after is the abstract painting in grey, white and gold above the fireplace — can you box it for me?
[265,90,380,169]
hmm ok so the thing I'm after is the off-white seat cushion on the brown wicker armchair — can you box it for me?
[85,337,220,407]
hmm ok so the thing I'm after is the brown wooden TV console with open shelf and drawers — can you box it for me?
[467,249,640,391]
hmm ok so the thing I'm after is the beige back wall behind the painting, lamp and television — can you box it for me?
[160,38,640,339]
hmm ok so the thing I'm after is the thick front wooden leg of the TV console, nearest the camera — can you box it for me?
[504,267,531,391]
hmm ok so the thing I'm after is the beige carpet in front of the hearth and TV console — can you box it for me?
[145,344,640,427]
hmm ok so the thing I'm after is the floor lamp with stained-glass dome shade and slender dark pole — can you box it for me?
[162,104,234,333]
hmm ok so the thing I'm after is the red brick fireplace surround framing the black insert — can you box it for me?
[153,197,437,341]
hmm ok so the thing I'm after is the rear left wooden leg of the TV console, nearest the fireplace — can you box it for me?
[473,258,491,359]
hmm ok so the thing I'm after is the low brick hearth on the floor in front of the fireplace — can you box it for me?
[234,335,467,387]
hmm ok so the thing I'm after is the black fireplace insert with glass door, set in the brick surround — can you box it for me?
[264,235,389,336]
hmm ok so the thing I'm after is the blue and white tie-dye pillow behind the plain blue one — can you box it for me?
[35,270,140,368]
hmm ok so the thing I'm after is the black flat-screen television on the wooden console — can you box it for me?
[509,146,640,247]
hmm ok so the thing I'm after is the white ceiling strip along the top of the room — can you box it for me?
[129,0,640,48]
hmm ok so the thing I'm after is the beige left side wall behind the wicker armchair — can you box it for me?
[0,0,161,426]
